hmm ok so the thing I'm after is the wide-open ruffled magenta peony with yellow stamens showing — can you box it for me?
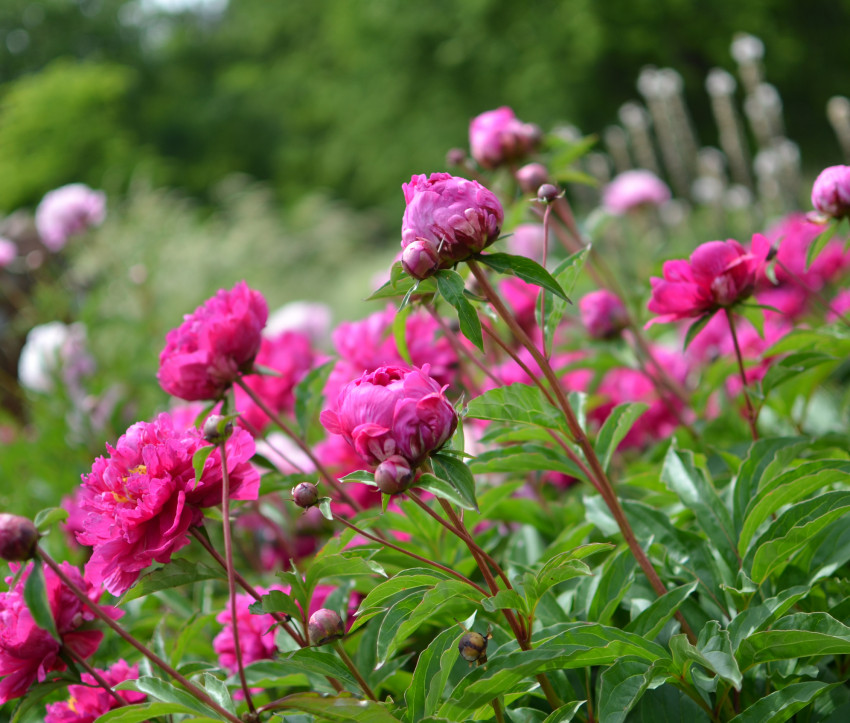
[77,414,260,595]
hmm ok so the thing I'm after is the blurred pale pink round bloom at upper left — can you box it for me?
[35,183,106,251]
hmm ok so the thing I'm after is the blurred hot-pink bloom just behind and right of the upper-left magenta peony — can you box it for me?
[234,331,321,431]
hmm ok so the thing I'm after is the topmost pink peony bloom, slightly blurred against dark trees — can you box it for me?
[469,106,541,170]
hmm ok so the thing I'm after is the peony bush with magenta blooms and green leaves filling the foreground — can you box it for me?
[0,56,850,723]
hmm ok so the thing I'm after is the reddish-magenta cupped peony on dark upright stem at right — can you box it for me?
[647,234,770,326]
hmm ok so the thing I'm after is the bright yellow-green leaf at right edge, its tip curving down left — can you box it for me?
[744,492,850,585]
